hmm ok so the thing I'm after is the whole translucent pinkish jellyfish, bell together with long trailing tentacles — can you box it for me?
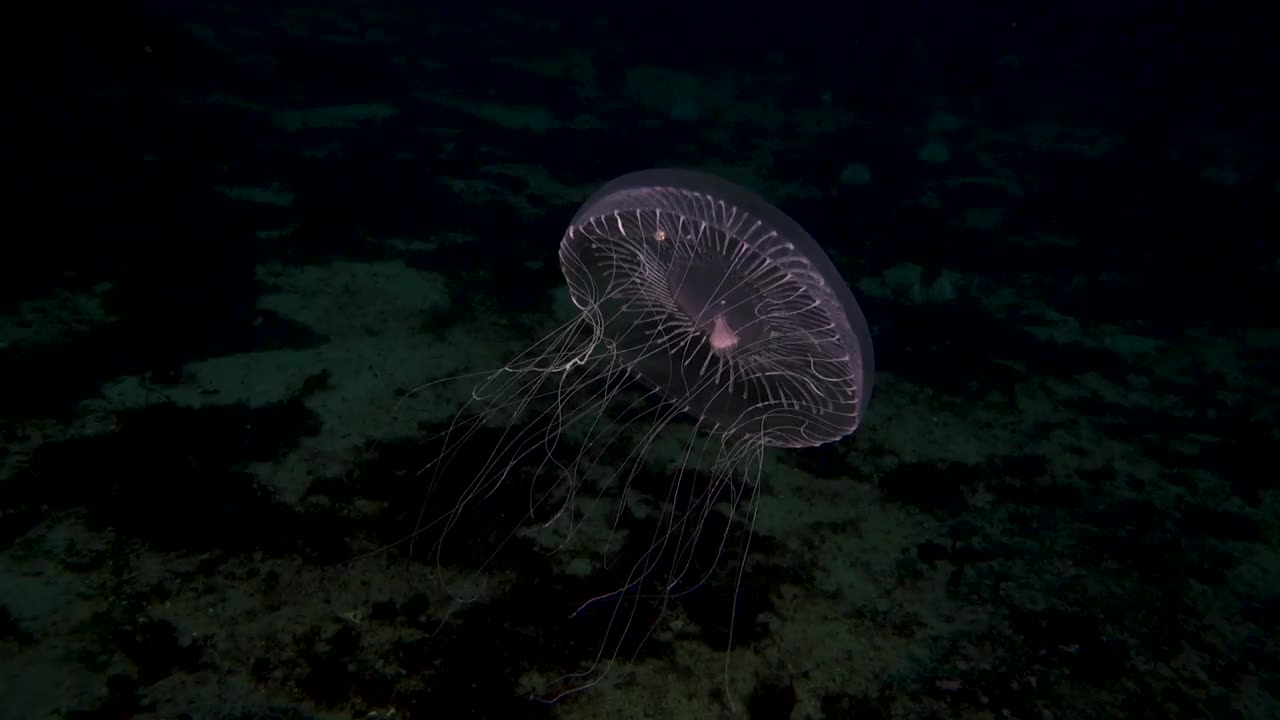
[428,169,873,700]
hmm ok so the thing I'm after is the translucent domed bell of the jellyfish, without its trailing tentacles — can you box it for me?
[559,169,874,447]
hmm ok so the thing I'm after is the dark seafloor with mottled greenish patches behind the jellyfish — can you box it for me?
[0,0,1280,720]
